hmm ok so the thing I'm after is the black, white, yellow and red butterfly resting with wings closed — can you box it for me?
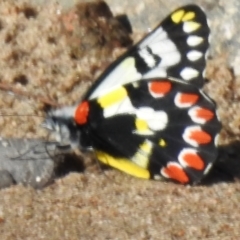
[43,5,221,184]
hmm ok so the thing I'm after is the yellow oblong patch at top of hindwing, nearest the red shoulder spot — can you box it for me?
[97,87,127,108]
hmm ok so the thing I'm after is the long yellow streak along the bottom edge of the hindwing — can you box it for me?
[96,151,150,179]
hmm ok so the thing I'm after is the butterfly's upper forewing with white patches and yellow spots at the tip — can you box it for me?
[85,5,210,99]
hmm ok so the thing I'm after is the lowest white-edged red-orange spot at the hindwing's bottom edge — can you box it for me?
[161,163,189,184]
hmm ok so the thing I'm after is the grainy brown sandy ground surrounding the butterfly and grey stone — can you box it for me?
[0,0,240,240]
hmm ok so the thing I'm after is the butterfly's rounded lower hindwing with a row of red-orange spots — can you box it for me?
[83,78,220,183]
